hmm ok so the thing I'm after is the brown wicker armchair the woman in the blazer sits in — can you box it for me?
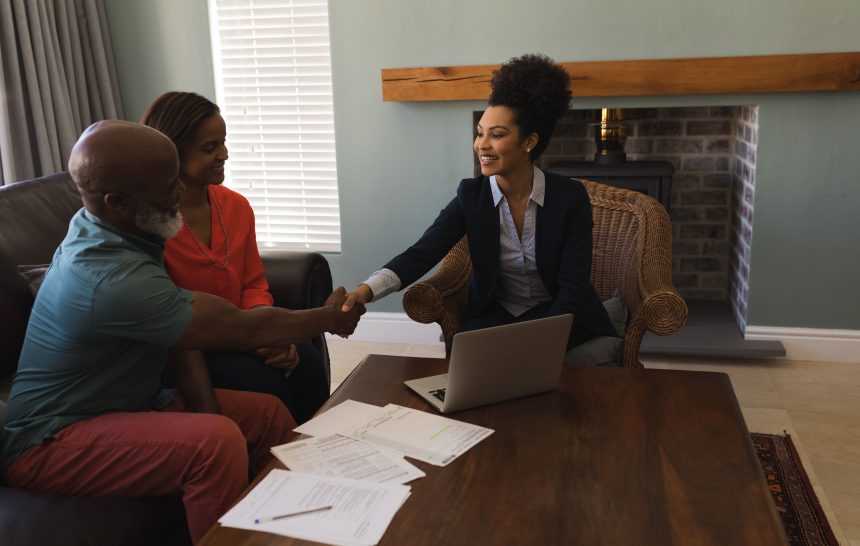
[403,180,687,367]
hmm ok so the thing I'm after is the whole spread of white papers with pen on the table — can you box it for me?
[219,400,493,546]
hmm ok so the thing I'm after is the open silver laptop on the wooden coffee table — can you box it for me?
[405,314,573,413]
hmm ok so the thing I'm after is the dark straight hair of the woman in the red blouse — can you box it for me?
[140,91,221,156]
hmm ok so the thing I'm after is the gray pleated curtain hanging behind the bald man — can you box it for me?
[0,0,122,185]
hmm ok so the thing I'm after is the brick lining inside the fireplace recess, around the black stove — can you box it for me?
[478,105,758,331]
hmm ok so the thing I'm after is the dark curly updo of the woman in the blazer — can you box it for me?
[489,54,571,161]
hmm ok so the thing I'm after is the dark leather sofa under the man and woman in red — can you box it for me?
[0,173,332,546]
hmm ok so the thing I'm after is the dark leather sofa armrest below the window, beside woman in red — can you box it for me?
[260,251,332,309]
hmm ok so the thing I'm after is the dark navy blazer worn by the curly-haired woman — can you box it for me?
[384,173,617,343]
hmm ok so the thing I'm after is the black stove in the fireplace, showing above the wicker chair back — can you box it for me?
[546,161,675,210]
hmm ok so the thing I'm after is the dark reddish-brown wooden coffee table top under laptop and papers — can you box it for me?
[201,355,787,546]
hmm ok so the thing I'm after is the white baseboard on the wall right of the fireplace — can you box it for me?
[744,326,860,364]
